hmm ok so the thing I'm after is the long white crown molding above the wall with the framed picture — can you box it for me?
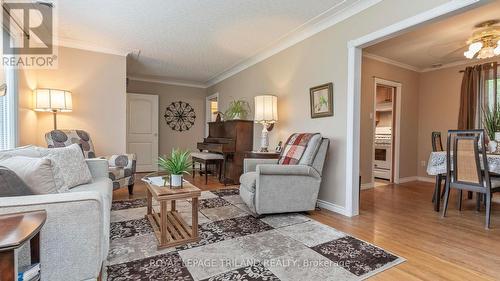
[206,0,382,87]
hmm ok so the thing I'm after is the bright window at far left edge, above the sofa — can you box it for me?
[0,65,17,150]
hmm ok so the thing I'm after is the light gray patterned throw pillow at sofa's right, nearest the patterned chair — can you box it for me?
[40,144,92,192]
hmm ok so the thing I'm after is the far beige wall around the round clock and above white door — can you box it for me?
[127,80,206,155]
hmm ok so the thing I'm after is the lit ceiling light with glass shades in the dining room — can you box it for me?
[464,20,500,59]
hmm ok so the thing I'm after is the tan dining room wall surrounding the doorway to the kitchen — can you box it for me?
[360,57,419,183]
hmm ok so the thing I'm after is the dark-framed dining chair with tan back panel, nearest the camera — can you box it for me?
[443,130,500,228]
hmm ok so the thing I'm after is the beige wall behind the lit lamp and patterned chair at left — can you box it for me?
[19,47,126,155]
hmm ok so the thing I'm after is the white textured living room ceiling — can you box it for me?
[57,0,357,83]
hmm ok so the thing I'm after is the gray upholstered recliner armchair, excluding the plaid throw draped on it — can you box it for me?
[240,134,330,215]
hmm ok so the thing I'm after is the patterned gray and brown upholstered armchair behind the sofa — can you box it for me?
[45,130,136,194]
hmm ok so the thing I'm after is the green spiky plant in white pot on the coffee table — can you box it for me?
[158,149,192,187]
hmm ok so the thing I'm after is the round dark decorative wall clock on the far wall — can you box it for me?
[163,101,196,132]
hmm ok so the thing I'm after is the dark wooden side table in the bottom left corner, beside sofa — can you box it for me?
[0,210,47,281]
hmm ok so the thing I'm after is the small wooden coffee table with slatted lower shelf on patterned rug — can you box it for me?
[143,176,201,249]
